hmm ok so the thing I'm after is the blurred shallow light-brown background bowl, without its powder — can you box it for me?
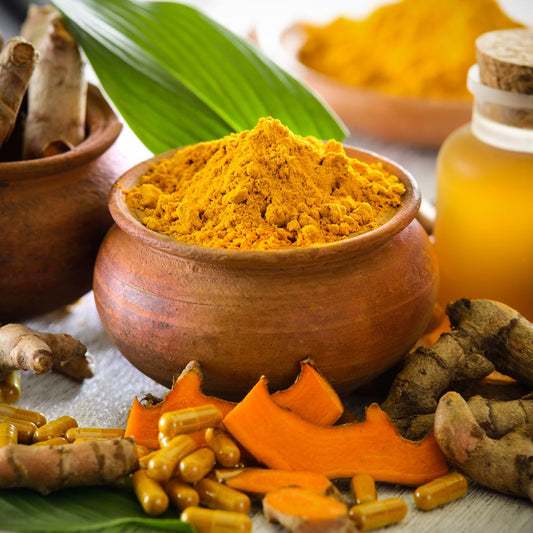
[257,24,472,147]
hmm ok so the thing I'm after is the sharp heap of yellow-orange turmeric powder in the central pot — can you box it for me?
[126,118,405,250]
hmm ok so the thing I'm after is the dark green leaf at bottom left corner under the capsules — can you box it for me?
[0,487,194,533]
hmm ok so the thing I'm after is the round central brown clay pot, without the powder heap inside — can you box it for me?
[94,148,438,399]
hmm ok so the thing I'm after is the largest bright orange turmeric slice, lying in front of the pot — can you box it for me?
[223,378,448,485]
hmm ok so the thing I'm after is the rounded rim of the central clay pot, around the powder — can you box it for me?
[109,145,421,267]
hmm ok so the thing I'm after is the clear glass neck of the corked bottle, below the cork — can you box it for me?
[467,65,533,153]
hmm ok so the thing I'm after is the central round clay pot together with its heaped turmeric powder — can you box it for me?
[93,118,438,399]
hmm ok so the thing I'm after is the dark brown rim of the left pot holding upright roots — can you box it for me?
[0,84,122,181]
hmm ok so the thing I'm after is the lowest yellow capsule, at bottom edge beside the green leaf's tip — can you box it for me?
[180,507,252,533]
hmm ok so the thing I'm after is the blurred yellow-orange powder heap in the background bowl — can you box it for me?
[299,0,523,99]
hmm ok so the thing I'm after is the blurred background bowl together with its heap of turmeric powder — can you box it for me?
[257,0,523,146]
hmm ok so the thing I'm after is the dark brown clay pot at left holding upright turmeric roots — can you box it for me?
[0,86,133,323]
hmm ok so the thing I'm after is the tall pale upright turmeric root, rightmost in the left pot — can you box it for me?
[23,14,87,159]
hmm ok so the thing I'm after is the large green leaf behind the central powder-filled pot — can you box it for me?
[52,0,346,153]
